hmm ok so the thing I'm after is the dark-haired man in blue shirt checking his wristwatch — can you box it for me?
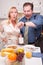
[19,2,42,44]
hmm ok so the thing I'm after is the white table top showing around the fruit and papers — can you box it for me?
[0,45,42,65]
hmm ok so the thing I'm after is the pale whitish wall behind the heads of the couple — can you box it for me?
[0,0,43,18]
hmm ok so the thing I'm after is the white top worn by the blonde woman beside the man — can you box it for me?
[2,20,20,44]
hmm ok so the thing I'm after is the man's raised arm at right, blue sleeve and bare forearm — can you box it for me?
[25,15,43,27]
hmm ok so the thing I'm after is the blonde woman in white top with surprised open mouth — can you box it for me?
[0,7,20,44]
